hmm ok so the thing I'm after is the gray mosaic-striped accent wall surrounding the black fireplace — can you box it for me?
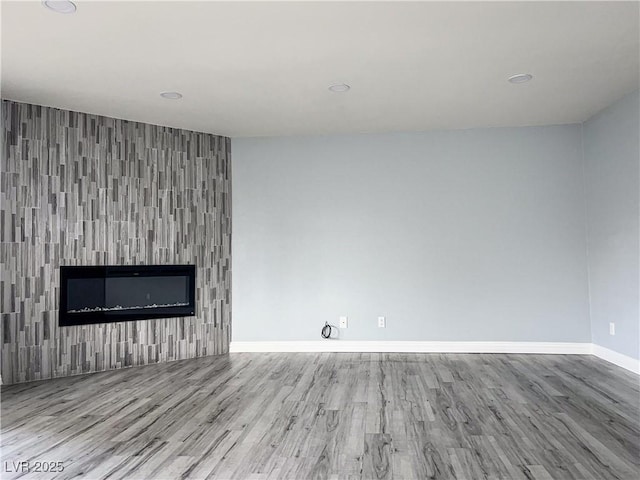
[0,101,231,384]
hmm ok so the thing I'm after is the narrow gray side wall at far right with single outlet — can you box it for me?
[583,91,640,358]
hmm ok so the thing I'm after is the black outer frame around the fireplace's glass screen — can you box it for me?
[58,265,196,327]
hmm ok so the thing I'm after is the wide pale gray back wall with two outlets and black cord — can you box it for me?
[232,125,590,342]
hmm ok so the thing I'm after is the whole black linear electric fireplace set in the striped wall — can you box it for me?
[59,265,196,326]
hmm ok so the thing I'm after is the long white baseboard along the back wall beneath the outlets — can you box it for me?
[229,340,591,355]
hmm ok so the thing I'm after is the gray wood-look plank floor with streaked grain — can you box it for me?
[1,353,640,480]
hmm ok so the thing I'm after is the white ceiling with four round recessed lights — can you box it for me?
[1,0,640,137]
